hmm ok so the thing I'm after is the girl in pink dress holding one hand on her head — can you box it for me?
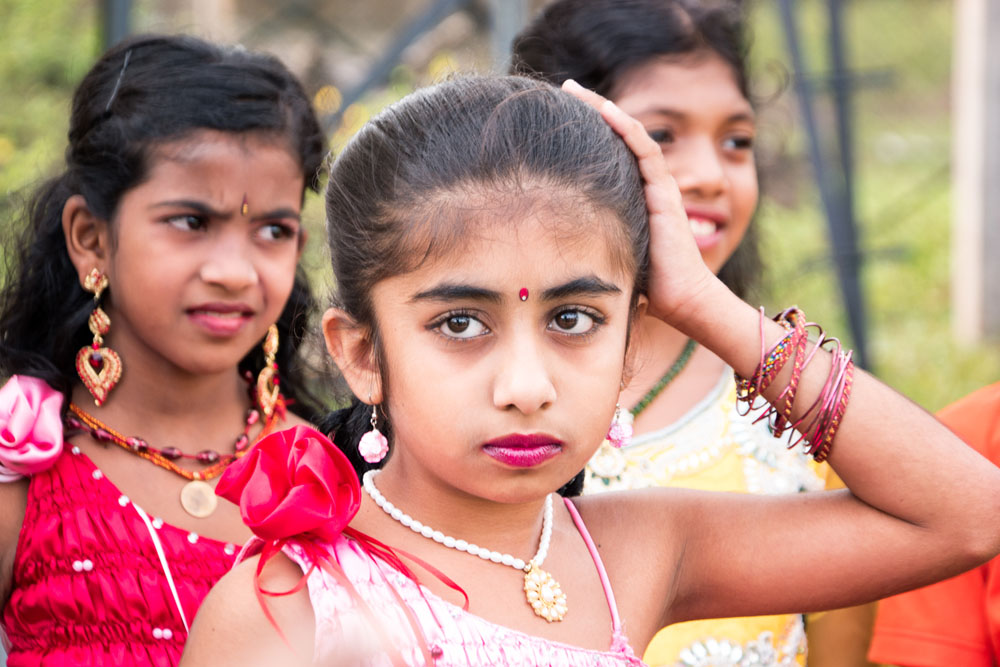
[182,77,1000,665]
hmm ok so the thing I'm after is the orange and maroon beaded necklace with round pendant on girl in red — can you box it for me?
[65,384,284,519]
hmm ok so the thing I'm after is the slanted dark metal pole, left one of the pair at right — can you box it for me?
[778,0,870,368]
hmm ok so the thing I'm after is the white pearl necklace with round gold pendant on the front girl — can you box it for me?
[361,470,567,623]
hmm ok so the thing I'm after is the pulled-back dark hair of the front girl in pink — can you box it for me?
[324,76,649,496]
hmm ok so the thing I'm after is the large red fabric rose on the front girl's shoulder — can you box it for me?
[215,426,361,541]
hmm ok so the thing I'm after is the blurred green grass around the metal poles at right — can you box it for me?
[752,0,1000,410]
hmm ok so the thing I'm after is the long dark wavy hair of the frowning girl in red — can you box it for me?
[0,35,325,416]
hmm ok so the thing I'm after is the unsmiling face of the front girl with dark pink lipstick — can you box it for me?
[368,198,632,502]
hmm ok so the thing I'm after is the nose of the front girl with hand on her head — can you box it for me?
[493,335,556,415]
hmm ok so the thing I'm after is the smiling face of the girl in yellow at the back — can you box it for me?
[613,53,758,273]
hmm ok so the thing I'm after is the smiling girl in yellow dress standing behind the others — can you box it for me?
[512,0,871,666]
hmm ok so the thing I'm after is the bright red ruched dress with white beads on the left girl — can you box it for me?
[3,443,236,667]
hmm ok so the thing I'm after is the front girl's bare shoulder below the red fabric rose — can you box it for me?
[181,554,316,667]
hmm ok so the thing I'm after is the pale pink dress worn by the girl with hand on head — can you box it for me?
[285,499,643,667]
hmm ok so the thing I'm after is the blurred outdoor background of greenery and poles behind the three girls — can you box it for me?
[0,0,1000,410]
